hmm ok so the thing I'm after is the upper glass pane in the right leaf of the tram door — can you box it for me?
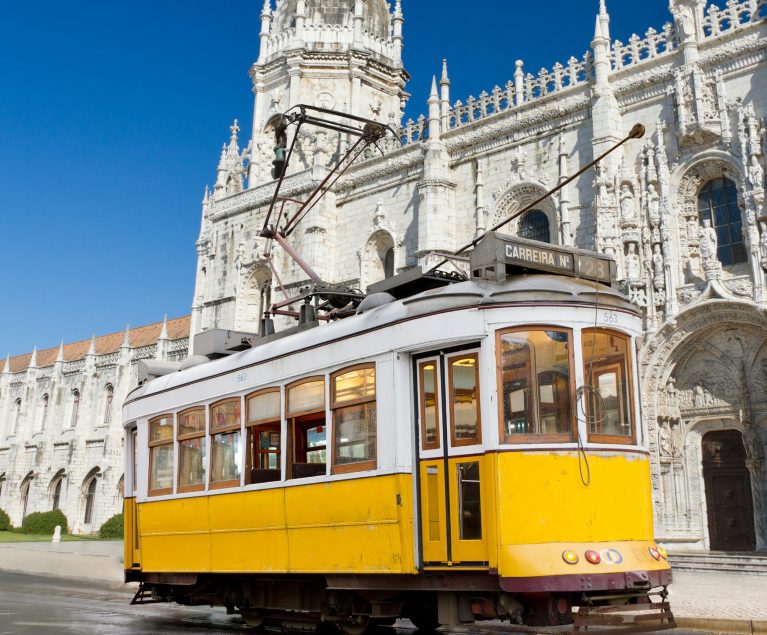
[448,353,482,446]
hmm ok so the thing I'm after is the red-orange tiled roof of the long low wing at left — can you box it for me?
[5,315,191,373]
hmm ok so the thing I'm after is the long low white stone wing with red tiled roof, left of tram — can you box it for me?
[0,317,190,533]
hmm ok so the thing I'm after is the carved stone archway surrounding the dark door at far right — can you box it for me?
[641,300,767,548]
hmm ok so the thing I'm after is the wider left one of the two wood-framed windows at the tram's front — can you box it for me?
[498,327,574,443]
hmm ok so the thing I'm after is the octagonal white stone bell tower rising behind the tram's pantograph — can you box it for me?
[248,0,409,188]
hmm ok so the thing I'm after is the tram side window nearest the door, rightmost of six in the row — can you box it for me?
[331,365,376,473]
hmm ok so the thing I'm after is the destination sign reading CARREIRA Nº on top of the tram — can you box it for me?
[471,233,616,284]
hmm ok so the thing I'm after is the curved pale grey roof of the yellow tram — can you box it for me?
[129,274,638,408]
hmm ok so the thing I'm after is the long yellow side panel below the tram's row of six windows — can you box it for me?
[134,474,415,574]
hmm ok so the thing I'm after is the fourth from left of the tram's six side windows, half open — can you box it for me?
[246,388,281,483]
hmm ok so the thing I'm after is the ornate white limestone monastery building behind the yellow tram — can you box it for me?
[0,0,767,551]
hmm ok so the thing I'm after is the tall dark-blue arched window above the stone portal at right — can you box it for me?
[698,177,748,266]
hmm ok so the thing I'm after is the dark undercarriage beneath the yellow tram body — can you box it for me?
[132,572,676,635]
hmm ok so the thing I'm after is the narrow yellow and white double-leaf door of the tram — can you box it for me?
[415,348,488,569]
